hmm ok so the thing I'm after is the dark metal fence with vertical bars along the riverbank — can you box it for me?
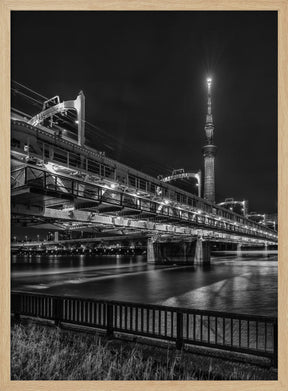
[11,292,278,366]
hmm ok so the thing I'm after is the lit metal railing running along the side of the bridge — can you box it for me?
[12,166,275,241]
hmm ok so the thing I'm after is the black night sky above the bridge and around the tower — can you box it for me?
[11,11,277,213]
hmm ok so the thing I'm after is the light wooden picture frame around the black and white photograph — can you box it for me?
[0,0,288,391]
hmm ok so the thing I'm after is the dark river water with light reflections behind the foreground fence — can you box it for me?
[11,255,278,316]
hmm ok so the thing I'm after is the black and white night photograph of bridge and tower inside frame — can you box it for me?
[10,10,278,382]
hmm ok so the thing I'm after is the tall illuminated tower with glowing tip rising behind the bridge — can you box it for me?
[202,77,217,202]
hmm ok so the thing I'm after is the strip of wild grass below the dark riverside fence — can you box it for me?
[11,324,277,380]
